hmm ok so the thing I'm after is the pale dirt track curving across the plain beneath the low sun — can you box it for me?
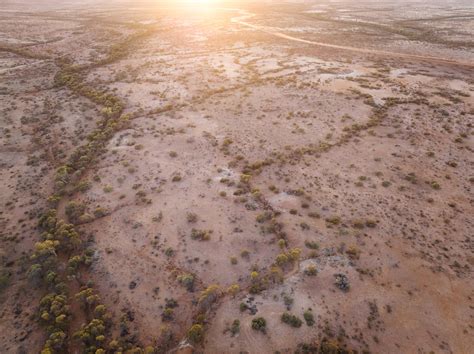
[231,10,474,68]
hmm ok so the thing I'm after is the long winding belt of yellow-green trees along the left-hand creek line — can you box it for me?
[32,22,161,354]
